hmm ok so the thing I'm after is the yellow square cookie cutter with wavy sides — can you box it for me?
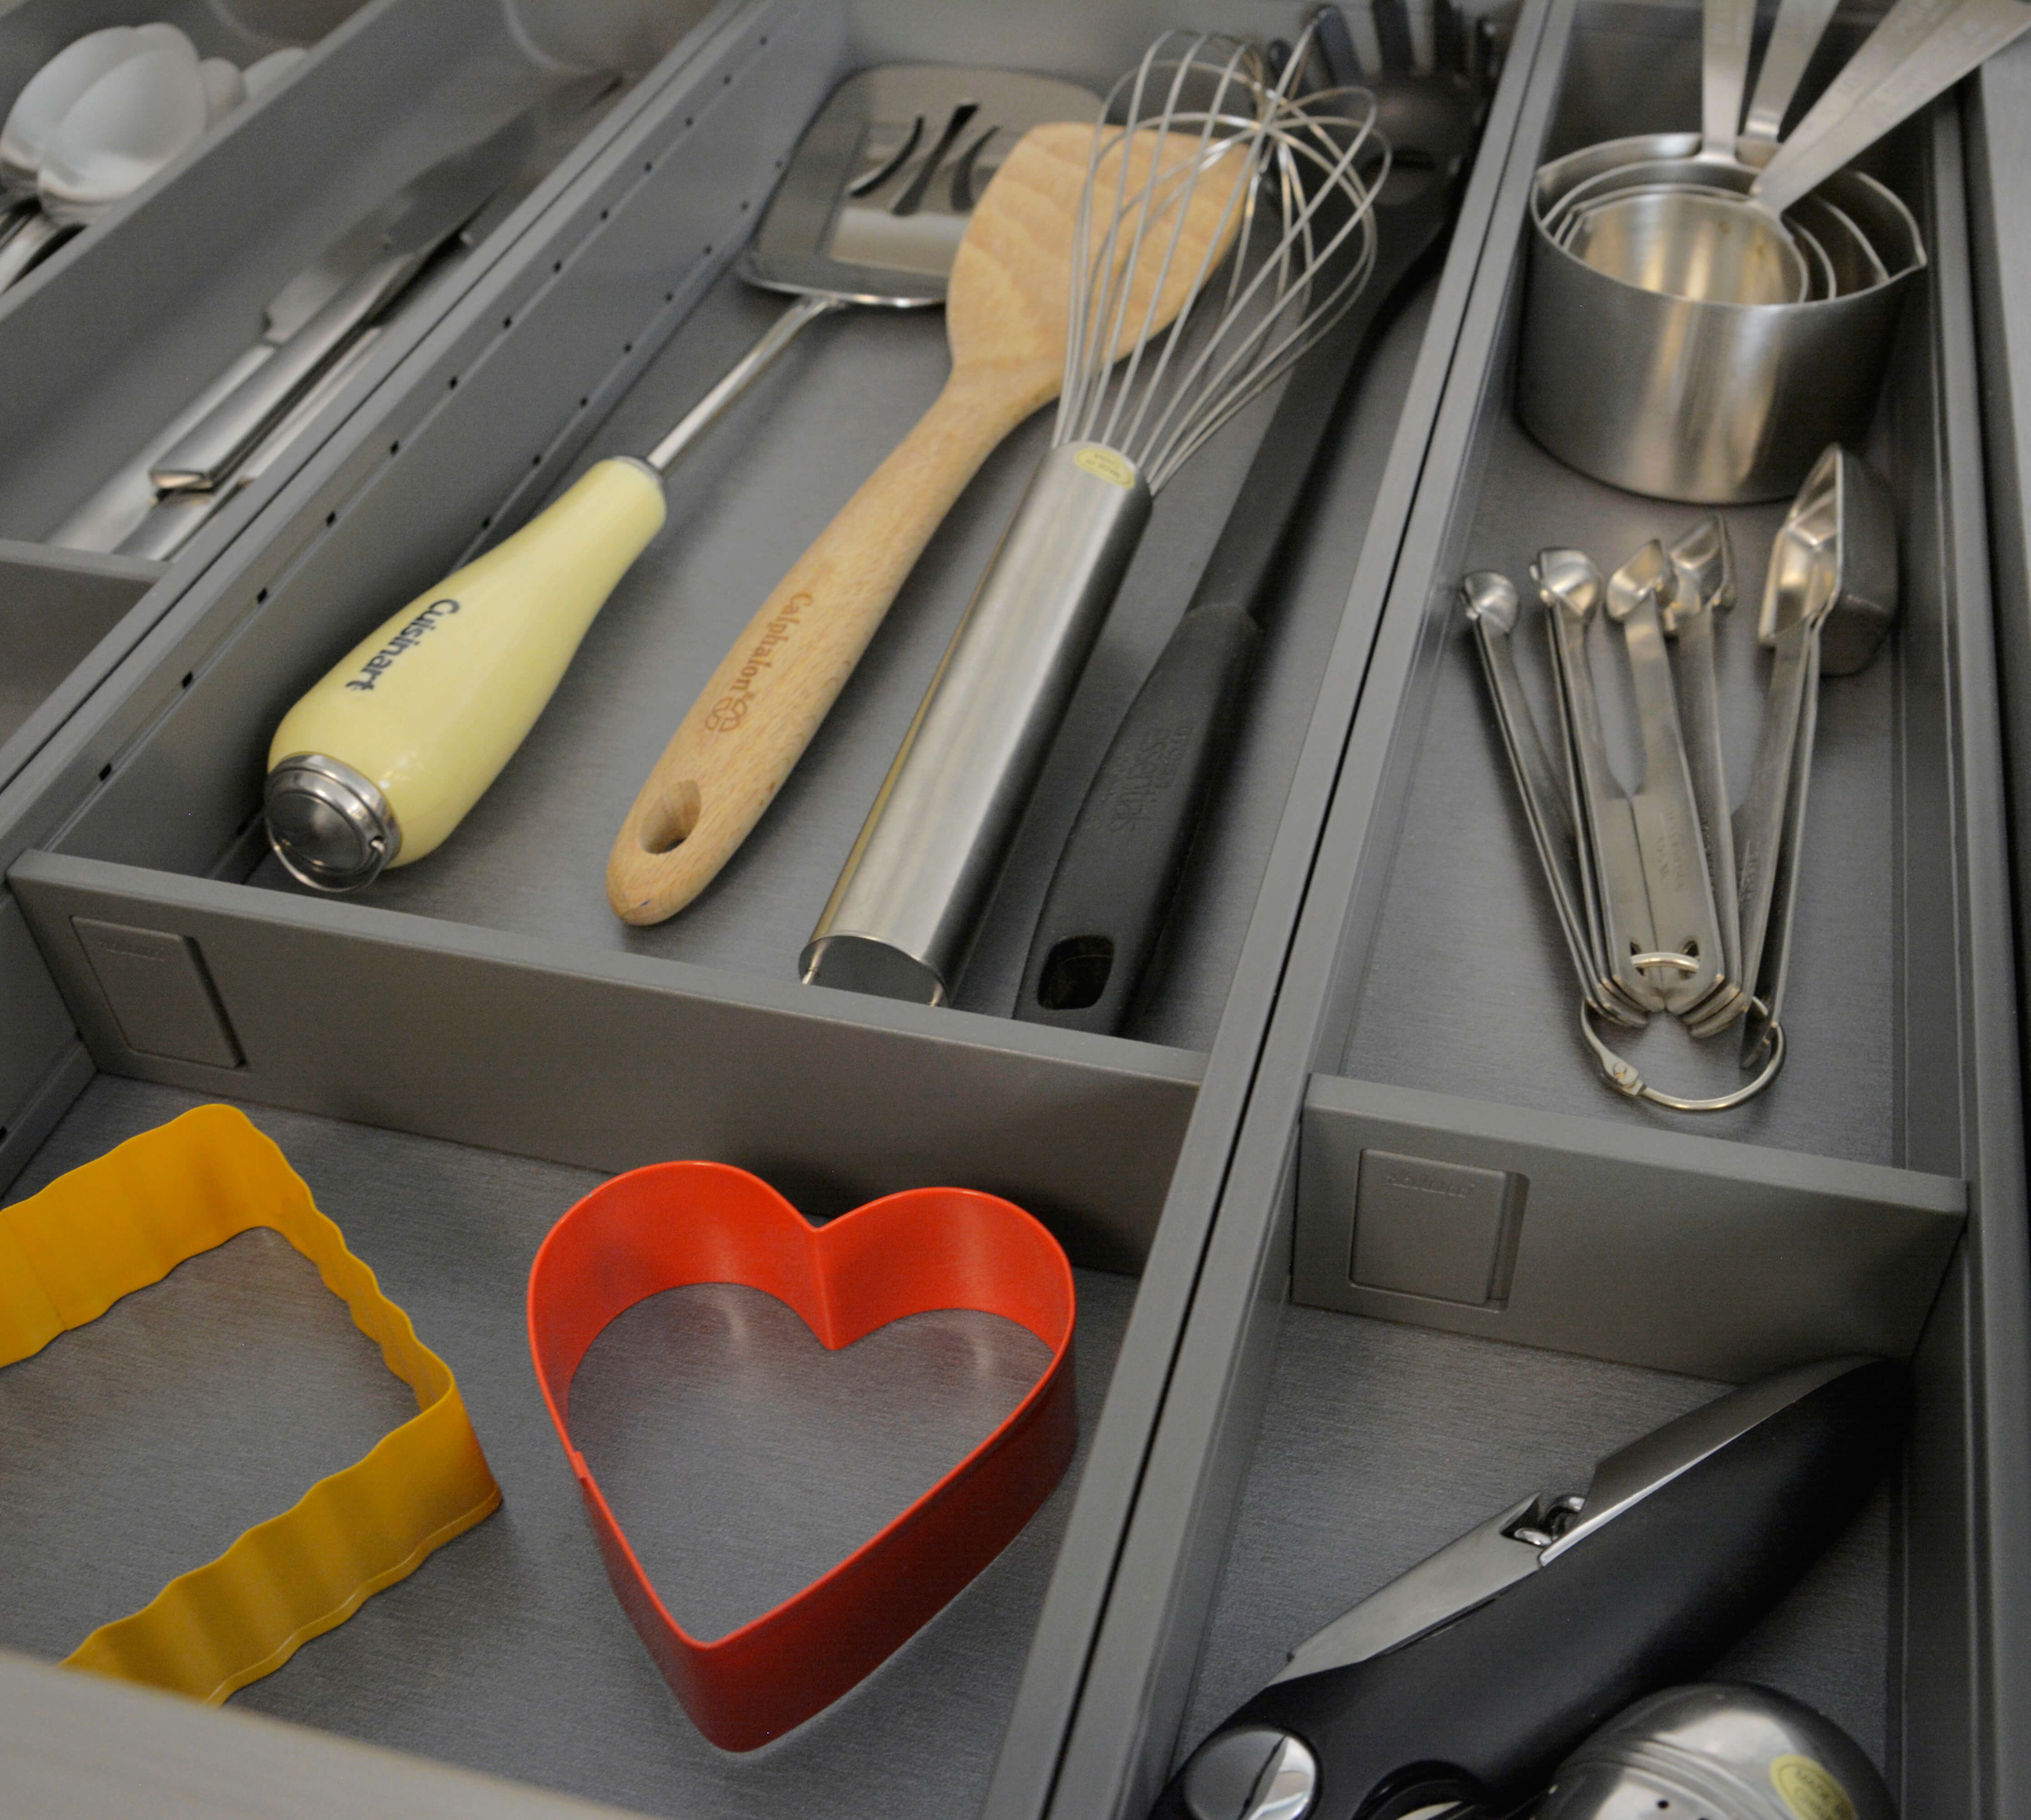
[0,1105,502,1706]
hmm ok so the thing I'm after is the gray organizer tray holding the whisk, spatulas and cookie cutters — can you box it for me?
[0,0,1541,1814]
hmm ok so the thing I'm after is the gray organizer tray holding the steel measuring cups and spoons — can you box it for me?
[1048,10,2031,1820]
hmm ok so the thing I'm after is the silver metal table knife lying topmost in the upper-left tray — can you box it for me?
[150,110,536,491]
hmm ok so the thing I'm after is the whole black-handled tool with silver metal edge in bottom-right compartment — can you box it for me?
[1154,1359,1909,1820]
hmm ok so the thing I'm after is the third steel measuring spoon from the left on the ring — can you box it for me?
[1608,538,1726,1016]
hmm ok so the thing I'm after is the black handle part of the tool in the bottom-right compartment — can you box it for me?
[1156,1361,1907,1820]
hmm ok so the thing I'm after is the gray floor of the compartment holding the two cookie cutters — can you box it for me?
[0,1079,1133,1820]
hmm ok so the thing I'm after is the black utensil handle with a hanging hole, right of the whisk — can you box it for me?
[1016,607,1261,1030]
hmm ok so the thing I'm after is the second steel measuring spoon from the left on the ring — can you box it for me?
[1531,551,1663,1011]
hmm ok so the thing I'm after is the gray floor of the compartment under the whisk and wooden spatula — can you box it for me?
[233,276,1430,1050]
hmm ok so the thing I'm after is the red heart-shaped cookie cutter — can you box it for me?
[528,1162,1078,1751]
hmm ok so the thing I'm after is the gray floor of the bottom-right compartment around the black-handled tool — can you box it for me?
[1178,1306,1895,1763]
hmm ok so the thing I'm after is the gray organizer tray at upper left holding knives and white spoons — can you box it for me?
[0,0,703,804]
